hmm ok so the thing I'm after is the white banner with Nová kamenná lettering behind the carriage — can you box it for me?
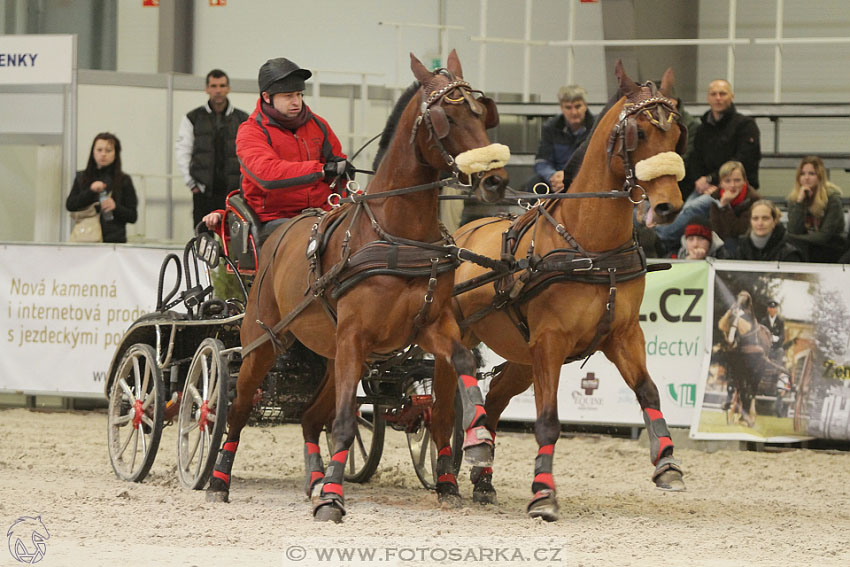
[0,244,181,397]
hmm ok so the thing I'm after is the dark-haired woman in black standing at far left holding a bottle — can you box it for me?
[65,132,138,242]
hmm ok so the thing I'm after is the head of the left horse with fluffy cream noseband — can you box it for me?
[410,50,510,202]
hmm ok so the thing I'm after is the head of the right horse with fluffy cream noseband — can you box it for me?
[608,61,688,226]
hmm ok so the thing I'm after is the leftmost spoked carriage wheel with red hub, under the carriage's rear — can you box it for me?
[107,343,165,482]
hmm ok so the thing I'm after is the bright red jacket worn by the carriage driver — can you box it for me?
[236,99,345,222]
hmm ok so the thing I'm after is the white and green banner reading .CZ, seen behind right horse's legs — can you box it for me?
[482,262,710,426]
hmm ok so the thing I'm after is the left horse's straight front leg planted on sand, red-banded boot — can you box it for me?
[313,338,368,523]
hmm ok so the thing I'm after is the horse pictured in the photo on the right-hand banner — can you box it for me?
[717,291,770,427]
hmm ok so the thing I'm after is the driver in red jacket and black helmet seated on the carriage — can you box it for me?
[204,57,354,240]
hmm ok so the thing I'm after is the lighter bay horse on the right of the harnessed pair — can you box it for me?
[434,61,687,521]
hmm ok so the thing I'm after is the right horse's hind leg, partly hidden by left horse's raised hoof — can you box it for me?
[469,362,532,504]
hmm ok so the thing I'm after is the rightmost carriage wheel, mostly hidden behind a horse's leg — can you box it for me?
[407,377,463,490]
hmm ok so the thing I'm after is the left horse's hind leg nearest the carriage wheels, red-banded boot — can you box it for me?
[206,342,276,502]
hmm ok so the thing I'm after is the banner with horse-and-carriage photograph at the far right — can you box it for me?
[691,262,850,442]
